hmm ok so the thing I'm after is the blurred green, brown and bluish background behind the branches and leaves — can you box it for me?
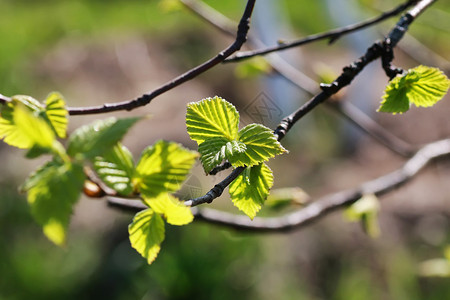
[0,0,450,300]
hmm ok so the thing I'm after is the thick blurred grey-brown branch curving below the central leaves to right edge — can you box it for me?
[108,139,450,232]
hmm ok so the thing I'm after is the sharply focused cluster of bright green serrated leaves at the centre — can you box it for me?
[186,96,286,219]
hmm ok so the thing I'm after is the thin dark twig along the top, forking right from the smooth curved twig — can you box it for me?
[225,0,417,62]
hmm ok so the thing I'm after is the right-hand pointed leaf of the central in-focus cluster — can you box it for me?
[227,124,286,167]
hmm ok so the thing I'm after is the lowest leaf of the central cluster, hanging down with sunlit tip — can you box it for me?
[229,163,273,219]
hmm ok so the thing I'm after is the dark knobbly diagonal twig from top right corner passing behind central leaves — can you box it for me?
[185,0,436,206]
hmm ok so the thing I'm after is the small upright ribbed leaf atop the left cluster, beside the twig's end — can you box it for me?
[45,92,68,138]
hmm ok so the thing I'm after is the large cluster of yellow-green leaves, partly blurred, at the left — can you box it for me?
[0,93,198,263]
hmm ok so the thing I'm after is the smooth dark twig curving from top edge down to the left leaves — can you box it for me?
[68,0,256,115]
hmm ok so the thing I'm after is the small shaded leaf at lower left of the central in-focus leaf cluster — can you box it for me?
[198,137,246,174]
